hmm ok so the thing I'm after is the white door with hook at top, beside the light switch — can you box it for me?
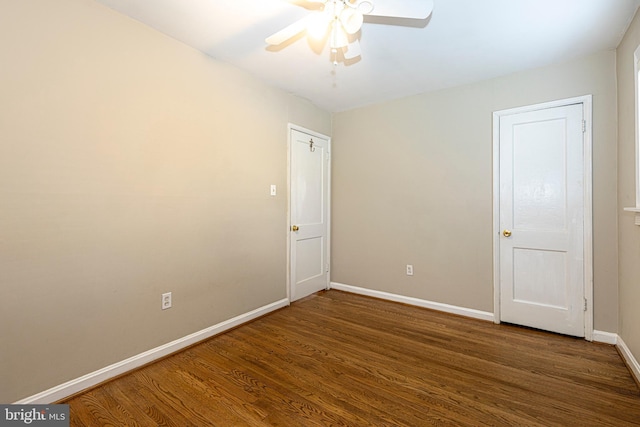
[289,128,330,301]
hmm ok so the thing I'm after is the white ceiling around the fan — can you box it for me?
[96,0,640,112]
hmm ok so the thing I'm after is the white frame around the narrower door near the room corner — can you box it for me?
[286,123,332,304]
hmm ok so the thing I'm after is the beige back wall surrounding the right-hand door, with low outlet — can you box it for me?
[331,51,618,332]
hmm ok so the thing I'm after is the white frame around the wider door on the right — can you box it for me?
[493,95,593,341]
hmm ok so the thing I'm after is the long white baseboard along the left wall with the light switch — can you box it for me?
[15,299,289,404]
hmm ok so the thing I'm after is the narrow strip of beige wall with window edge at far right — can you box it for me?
[617,10,640,370]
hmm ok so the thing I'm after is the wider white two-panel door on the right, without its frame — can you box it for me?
[499,104,585,337]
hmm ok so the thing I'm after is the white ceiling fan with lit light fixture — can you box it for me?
[265,0,433,64]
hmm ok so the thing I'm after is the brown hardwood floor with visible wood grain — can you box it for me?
[63,291,640,427]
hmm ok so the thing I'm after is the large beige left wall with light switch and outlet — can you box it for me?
[0,0,331,403]
